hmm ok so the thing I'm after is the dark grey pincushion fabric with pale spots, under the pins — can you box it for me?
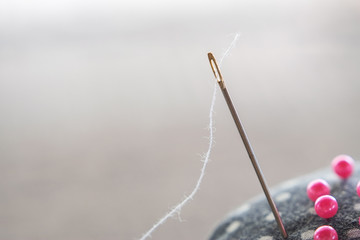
[210,165,360,240]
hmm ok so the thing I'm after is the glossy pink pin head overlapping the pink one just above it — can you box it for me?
[315,195,338,218]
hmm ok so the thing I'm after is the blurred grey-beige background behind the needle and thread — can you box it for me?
[0,0,360,240]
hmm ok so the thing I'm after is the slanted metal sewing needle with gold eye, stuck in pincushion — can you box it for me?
[208,53,288,238]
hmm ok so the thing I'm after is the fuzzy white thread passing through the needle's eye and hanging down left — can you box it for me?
[140,33,240,240]
